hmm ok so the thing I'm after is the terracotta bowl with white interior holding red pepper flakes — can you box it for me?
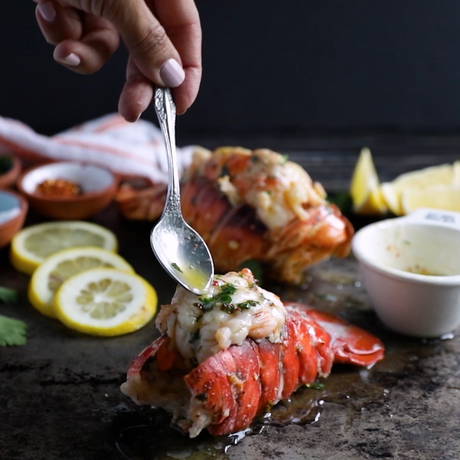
[17,162,118,220]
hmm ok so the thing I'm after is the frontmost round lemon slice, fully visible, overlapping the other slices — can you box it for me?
[53,268,157,336]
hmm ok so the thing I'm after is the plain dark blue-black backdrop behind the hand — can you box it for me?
[0,0,460,138]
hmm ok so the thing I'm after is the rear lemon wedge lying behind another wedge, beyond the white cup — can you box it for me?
[382,164,452,216]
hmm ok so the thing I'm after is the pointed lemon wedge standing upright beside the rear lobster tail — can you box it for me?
[350,147,387,215]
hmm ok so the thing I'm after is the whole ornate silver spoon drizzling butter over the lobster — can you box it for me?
[150,88,214,295]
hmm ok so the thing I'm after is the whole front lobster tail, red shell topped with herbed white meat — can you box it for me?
[121,269,384,437]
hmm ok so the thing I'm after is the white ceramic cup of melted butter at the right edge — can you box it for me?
[352,209,460,338]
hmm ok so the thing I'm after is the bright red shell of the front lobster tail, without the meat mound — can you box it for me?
[122,304,384,437]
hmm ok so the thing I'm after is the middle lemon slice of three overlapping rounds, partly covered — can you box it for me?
[28,247,134,318]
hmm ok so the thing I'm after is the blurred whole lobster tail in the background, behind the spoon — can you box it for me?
[117,147,353,283]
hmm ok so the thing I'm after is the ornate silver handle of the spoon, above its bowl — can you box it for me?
[154,87,181,215]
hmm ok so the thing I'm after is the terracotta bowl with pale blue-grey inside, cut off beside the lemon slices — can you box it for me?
[0,190,28,248]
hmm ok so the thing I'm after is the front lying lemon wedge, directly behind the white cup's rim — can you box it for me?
[401,185,460,214]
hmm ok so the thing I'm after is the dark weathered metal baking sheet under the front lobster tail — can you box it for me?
[0,207,460,460]
